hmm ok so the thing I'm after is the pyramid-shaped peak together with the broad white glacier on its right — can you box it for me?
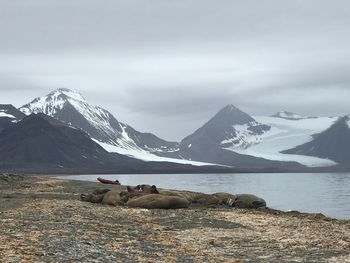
[164,105,338,167]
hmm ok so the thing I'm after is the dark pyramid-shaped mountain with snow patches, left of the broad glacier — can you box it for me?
[159,105,302,170]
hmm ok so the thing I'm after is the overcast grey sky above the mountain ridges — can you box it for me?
[0,0,350,140]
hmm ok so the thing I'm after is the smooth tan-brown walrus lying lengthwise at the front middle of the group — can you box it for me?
[126,194,190,209]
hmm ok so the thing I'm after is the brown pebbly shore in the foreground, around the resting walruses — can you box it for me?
[0,175,350,263]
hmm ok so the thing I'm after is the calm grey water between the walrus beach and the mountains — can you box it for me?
[56,173,350,219]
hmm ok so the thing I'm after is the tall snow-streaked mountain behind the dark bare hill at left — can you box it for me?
[20,88,178,156]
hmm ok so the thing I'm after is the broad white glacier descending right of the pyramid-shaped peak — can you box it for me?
[229,116,338,167]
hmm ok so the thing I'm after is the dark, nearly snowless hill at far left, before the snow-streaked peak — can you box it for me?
[0,114,127,173]
